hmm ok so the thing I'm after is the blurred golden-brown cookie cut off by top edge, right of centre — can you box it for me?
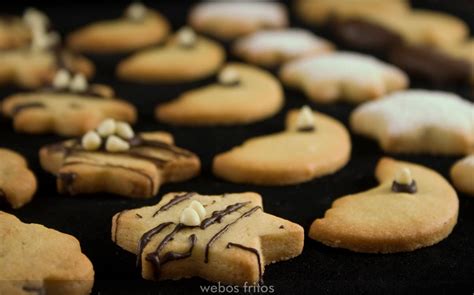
[295,0,409,25]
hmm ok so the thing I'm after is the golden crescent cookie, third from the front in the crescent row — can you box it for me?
[156,63,283,125]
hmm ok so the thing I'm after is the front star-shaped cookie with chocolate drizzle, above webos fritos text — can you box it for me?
[112,193,304,285]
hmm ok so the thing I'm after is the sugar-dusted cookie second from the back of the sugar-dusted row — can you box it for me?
[233,29,334,67]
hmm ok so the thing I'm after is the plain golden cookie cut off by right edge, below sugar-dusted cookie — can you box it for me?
[451,154,474,196]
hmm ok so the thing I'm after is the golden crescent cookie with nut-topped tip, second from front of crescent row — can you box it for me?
[212,107,351,185]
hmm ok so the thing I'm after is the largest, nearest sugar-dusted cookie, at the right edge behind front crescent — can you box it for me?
[350,90,474,155]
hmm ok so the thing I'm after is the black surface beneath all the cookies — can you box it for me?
[0,1,474,294]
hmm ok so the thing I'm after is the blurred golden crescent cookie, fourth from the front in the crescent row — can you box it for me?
[117,28,225,82]
